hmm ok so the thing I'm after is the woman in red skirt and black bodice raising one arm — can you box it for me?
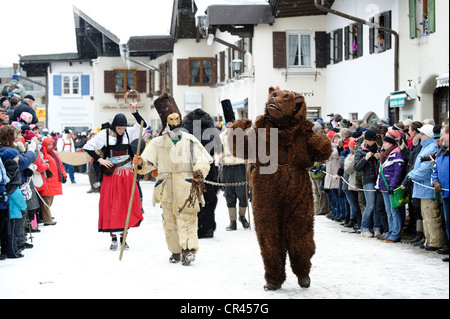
[83,103,147,250]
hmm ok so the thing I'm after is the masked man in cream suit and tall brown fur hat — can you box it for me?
[134,93,213,265]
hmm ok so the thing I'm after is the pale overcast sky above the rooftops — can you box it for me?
[0,0,267,67]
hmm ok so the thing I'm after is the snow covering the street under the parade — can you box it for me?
[0,174,449,299]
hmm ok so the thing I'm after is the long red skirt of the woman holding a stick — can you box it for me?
[98,167,144,232]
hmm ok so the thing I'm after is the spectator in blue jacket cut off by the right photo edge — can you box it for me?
[431,119,450,262]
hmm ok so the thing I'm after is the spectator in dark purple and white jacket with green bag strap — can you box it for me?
[377,131,405,243]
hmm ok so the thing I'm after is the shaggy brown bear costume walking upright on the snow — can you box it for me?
[229,87,332,290]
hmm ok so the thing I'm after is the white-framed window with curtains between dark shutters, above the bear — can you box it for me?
[288,33,312,68]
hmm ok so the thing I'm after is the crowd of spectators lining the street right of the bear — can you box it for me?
[310,119,449,262]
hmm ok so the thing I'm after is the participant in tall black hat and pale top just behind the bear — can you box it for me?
[220,100,249,231]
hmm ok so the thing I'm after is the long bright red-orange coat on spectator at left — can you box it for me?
[40,138,67,196]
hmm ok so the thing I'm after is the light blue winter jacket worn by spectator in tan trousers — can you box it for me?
[408,138,438,199]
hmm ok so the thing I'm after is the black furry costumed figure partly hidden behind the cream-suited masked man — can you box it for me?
[182,109,219,238]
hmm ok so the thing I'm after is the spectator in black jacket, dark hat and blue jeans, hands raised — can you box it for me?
[355,130,381,238]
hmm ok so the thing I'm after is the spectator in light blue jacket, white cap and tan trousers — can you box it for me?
[408,124,444,251]
